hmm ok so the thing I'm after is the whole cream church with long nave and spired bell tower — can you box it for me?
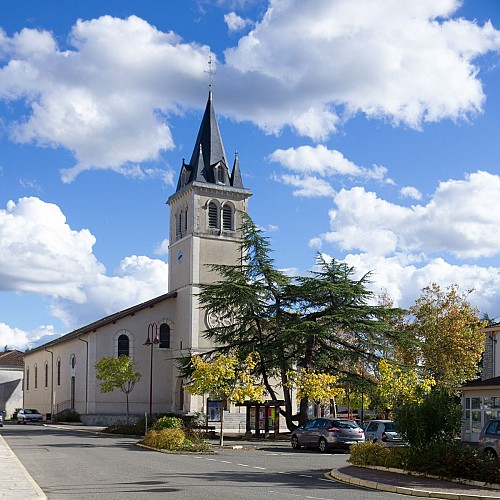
[23,90,252,425]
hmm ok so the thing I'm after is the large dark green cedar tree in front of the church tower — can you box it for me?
[188,214,406,429]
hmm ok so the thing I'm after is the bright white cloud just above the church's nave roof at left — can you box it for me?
[0,198,168,328]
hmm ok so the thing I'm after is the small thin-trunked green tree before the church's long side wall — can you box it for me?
[94,355,141,425]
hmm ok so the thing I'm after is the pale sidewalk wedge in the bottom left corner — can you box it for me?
[0,434,47,500]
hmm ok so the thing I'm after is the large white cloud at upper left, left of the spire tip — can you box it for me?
[0,16,209,182]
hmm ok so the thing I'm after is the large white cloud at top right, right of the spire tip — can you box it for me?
[222,0,500,140]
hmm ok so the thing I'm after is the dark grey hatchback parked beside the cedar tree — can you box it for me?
[291,417,365,452]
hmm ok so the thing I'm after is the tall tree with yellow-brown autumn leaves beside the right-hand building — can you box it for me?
[410,283,485,389]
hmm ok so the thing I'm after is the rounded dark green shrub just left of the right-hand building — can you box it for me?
[394,390,462,448]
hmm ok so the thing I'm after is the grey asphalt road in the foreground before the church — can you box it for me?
[2,425,407,500]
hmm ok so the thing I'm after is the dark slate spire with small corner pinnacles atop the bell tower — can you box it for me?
[177,90,243,191]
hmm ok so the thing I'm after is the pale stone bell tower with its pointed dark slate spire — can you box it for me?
[167,91,252,356]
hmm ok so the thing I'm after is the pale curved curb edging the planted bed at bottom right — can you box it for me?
[326,470,500,500]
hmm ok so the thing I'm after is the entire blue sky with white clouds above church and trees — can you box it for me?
[0,0,500,350]
